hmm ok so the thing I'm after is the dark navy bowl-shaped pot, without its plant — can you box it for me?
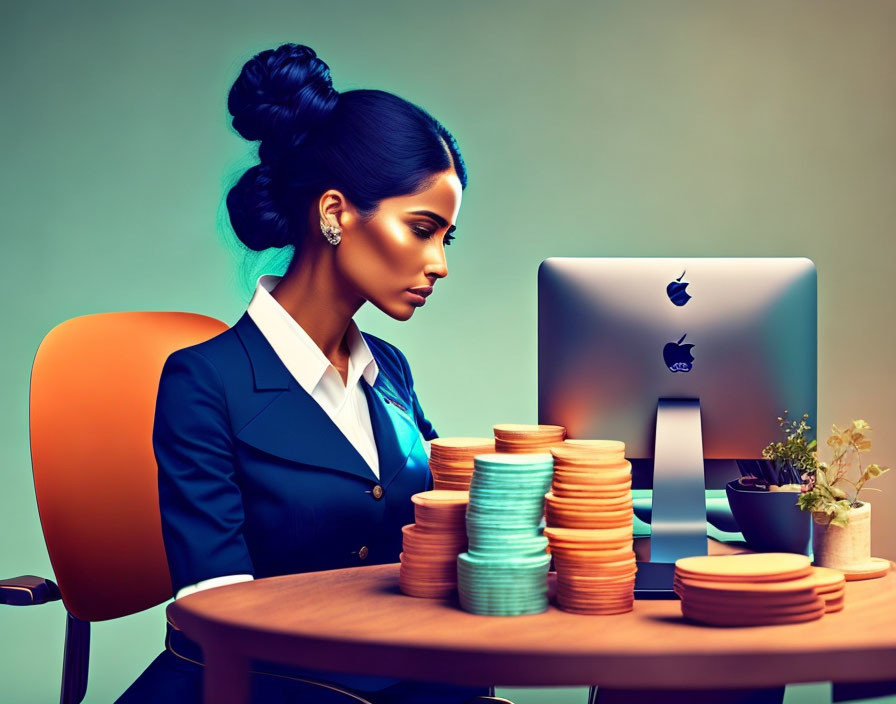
[725,480,812,555]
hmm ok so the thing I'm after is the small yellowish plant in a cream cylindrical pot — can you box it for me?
[798,420,890,573]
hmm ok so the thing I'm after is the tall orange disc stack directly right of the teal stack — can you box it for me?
[544,440,637,615]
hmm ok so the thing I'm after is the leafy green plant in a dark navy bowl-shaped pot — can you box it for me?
[725,411,817,555]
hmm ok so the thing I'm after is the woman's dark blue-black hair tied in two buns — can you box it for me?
[227,44,467,251]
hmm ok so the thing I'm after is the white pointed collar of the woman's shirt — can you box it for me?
[246,274,379,394]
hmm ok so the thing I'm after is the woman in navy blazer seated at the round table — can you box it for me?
[119,44,486,704]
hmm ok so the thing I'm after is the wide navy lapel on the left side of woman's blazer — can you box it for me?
[233,313,376,482]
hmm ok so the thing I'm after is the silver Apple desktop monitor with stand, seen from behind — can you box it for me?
[538,257,818,597]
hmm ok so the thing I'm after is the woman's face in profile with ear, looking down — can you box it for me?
[321,169,462,320]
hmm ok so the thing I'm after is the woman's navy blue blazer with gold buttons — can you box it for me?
[153,313,438,686]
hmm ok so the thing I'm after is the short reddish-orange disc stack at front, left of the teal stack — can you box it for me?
[398,490,470,598]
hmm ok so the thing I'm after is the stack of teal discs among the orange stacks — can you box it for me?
[457,453,554,616]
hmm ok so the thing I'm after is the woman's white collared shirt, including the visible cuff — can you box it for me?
[174,274,380,599]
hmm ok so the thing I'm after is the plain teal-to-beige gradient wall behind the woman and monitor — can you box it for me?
[0,0,896,704]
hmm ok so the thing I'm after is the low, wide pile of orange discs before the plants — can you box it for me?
[674,553,846,626]
